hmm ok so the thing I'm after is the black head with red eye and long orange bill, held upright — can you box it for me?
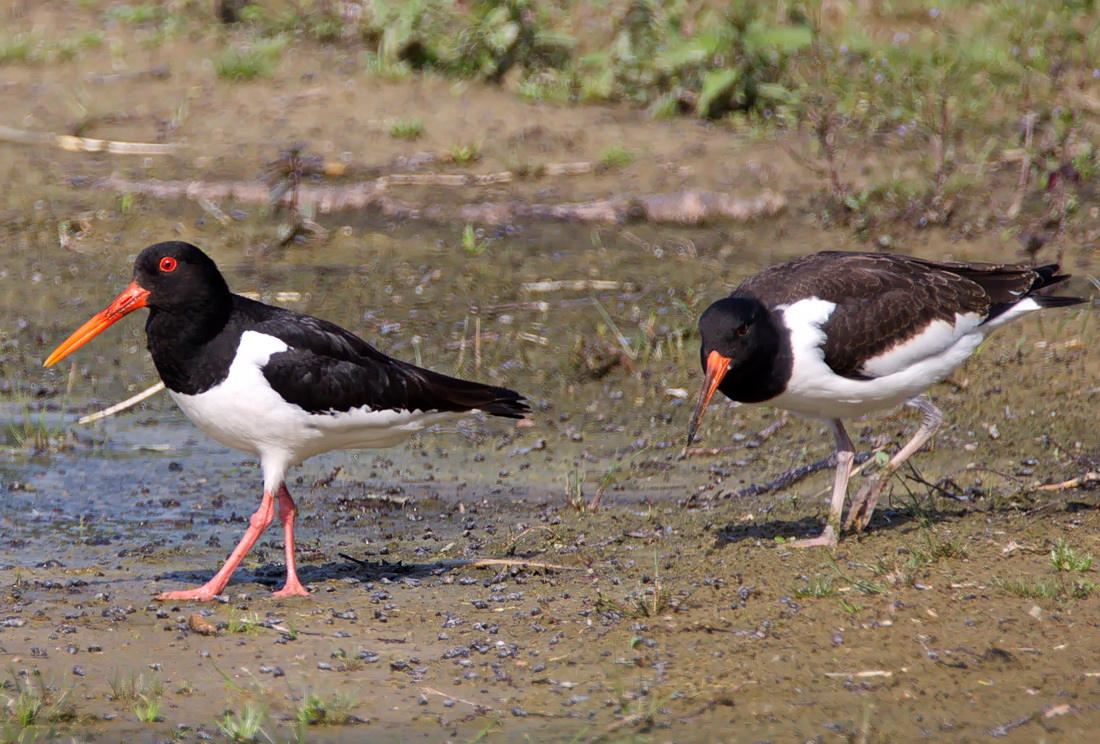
[45,241,232,366]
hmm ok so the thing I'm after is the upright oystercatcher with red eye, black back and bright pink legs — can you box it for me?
[45,241,530,600]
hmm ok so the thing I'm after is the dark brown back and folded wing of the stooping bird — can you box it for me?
[735,251,1067,378]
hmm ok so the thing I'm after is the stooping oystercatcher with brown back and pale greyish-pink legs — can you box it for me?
[688,251,1086,547]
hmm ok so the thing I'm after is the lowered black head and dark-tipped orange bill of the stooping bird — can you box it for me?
[688,296,777,446]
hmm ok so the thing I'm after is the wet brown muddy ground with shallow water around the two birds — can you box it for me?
[0,3,1100,742]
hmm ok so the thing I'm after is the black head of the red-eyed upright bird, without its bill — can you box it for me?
[134,240,230,313]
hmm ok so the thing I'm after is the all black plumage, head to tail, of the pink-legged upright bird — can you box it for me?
[134,242,530,418]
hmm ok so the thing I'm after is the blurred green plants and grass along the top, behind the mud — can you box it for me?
[0,0,1100,235]
